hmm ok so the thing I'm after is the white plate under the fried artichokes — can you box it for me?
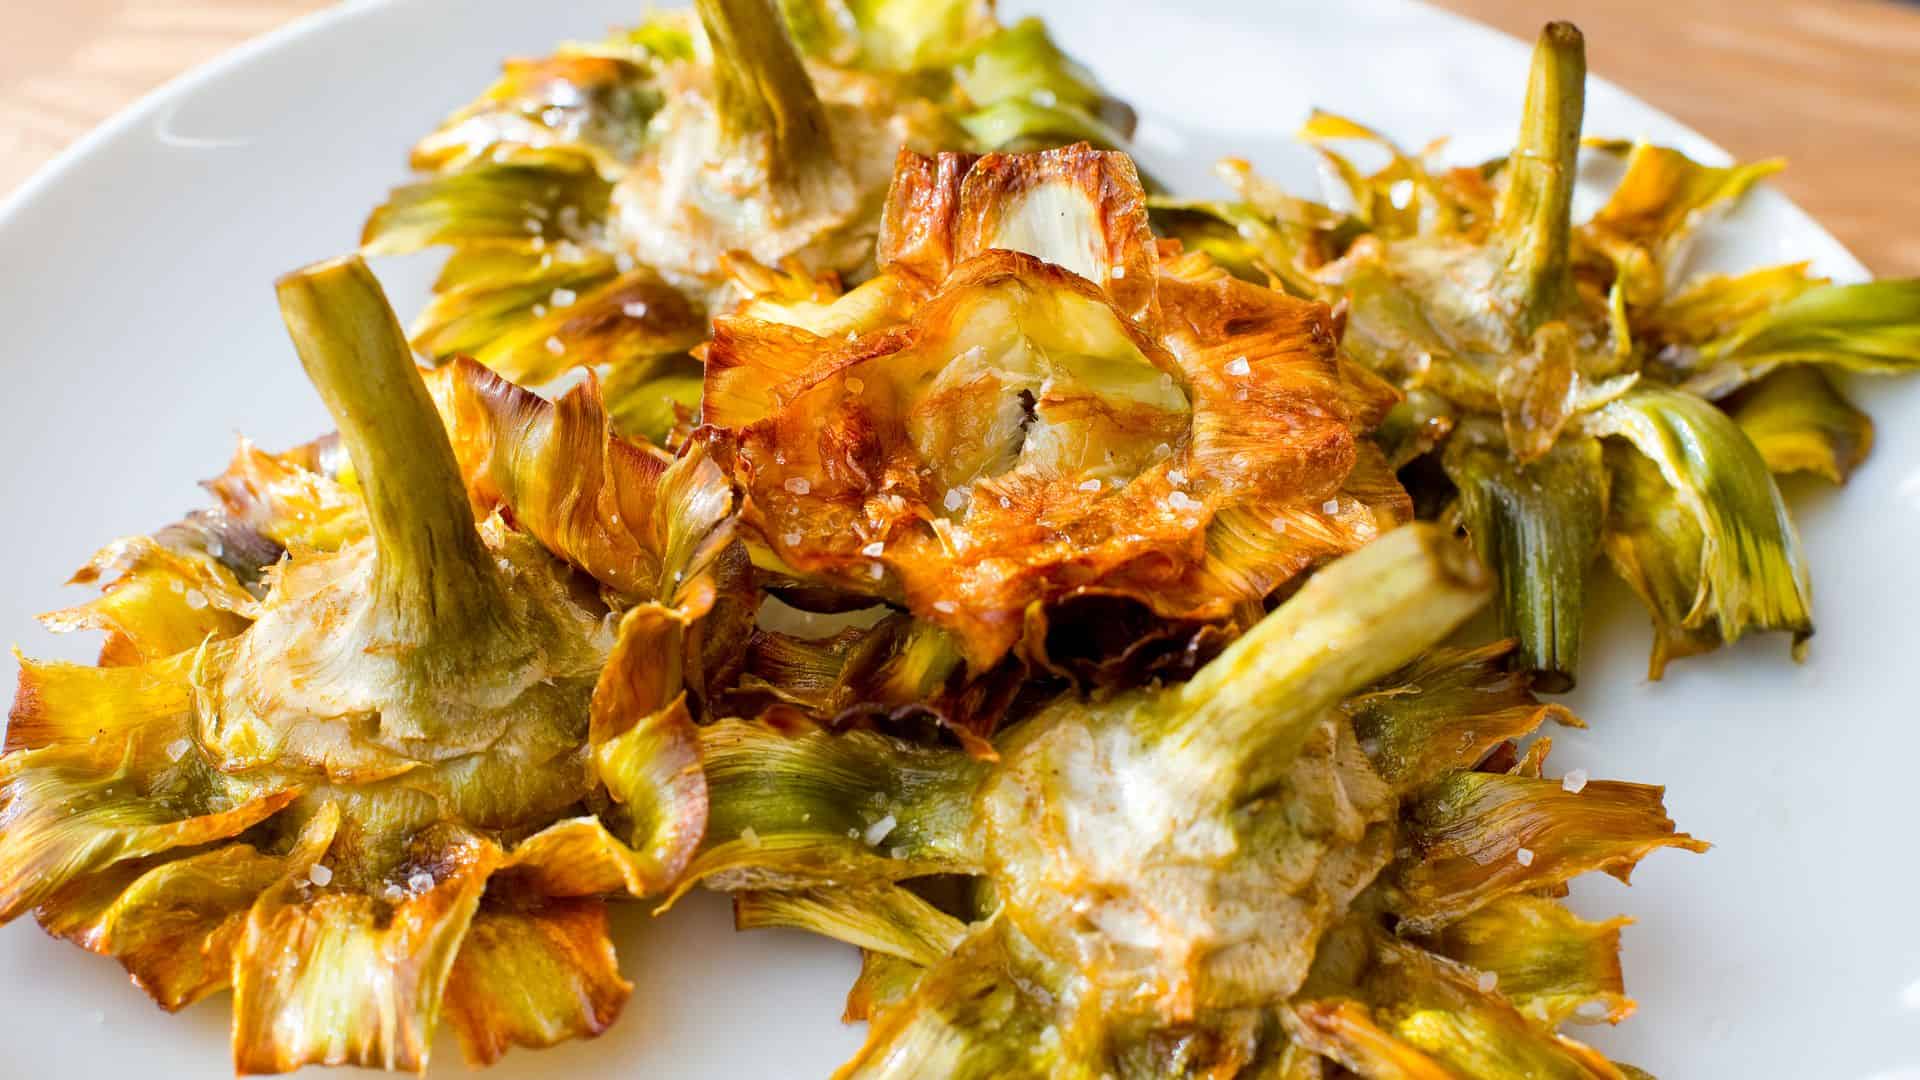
[0,0,1920,1080]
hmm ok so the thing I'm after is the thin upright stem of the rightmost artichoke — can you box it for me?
[1494,23,1586,338]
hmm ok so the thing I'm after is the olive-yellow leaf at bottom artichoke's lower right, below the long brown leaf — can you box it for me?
[1432,894,1634,1028]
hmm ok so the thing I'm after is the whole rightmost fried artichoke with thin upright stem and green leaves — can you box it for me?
[1156,23,1920,690]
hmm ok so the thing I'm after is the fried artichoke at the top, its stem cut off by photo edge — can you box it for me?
[363,0,1133,407]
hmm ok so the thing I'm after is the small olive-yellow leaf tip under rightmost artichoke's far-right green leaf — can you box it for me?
[1726,367,1874,484]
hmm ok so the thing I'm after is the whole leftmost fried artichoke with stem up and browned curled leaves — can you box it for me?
[0,259,732,1072]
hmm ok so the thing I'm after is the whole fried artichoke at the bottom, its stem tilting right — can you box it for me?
[683,525,1703,1080]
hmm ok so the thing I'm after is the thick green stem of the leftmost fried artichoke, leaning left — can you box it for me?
[276,256,507,644]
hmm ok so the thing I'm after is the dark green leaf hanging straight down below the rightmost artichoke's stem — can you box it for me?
[1442,422,1607,690]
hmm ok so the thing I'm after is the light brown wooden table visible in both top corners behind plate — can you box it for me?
[0,0,1920,275]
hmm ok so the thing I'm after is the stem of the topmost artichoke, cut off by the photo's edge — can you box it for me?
[697,0,845,192]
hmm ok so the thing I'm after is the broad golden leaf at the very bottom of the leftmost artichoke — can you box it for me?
[234,830,497,1072]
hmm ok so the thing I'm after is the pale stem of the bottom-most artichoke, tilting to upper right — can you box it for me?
[1165,525,1490,790]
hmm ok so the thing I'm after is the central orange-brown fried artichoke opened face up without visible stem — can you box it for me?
[701,144,1411,714]
